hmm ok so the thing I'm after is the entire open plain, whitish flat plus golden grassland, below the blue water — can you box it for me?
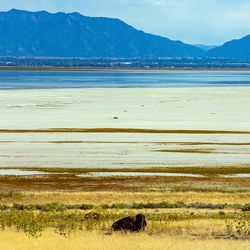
[0,87,250,250]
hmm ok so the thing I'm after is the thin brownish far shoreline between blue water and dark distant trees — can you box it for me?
[0,66,250,72]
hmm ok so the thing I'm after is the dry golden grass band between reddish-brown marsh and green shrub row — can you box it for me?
[0,192,250,204]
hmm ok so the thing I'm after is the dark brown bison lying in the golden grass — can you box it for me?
[112,214,147,232]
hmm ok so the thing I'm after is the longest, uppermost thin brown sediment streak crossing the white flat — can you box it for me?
[0,128,250,134]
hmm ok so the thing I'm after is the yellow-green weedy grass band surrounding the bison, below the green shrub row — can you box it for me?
[0,209,250,237]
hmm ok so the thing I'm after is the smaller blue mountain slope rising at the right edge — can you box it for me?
[206,35,250,59]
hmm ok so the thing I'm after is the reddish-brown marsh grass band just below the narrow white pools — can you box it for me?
[0,173,250,193]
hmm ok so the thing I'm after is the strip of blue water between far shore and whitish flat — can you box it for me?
[0,71,250,89]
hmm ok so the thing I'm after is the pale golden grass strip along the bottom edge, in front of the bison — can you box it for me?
[0,231,250,250]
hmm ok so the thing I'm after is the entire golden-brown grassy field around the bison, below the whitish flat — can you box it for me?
[0,166,250,250]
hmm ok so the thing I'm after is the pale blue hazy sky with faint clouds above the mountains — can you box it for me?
[0,0,250,44]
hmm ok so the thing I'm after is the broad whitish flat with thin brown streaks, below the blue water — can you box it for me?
[0,87,250,168]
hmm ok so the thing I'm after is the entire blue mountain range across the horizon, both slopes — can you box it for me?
[0,9,250,59]
